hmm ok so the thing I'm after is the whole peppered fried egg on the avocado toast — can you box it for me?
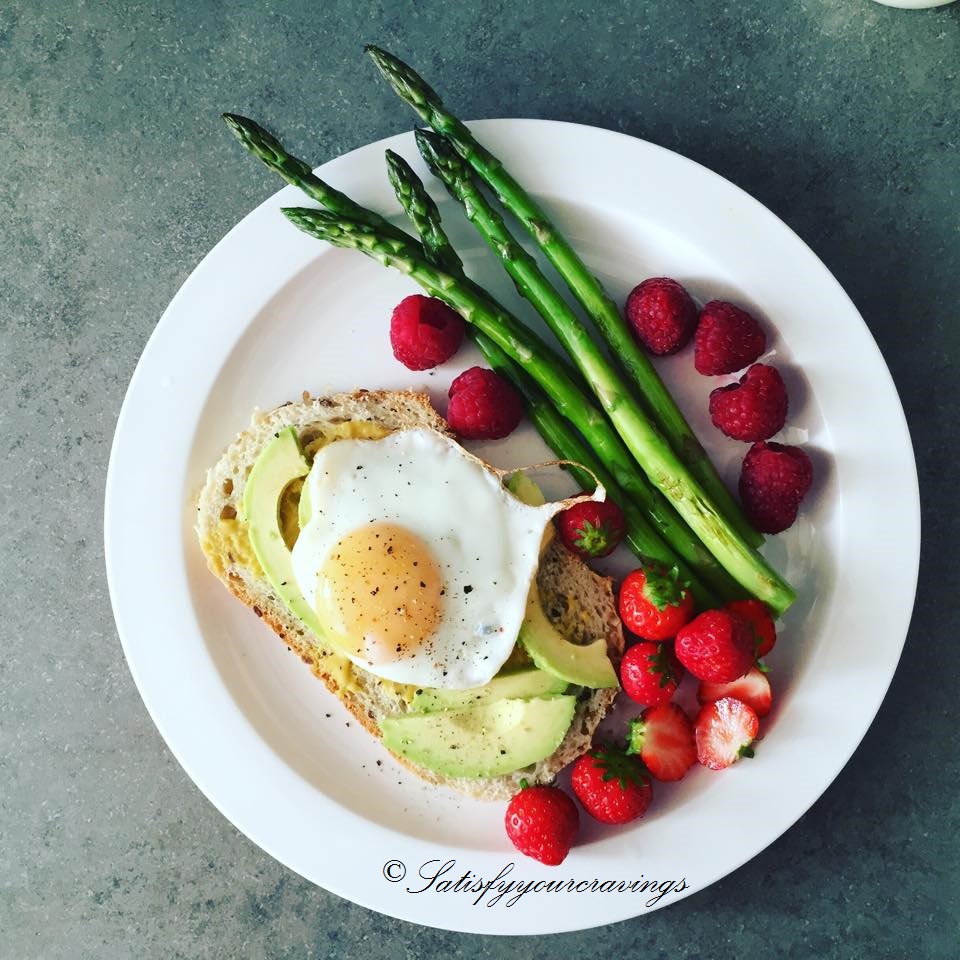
[293,429,603,690]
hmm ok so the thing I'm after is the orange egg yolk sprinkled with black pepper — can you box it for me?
[317,523,444,663]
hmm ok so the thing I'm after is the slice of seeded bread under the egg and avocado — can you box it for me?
[196,390,624,800]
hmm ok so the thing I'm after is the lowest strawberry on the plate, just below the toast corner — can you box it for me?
[504,780,580,867]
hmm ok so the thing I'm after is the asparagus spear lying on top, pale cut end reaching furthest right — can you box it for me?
[417,130,786,612]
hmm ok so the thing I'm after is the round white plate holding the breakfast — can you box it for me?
[105,120,919,934]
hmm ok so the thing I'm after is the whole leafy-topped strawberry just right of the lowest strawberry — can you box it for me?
[570,748,653,823]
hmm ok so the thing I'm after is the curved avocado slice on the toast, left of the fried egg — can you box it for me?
[240,427,324,637]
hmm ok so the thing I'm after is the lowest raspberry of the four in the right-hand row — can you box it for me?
[740,440,813,533]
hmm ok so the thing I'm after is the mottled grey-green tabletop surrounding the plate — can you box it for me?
[0,0,960,960]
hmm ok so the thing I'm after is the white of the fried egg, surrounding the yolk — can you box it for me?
[293,429,564,690]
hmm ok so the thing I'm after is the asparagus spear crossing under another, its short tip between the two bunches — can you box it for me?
[387,150,717,607]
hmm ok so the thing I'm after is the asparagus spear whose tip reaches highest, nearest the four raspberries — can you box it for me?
[366,46,763,546]
